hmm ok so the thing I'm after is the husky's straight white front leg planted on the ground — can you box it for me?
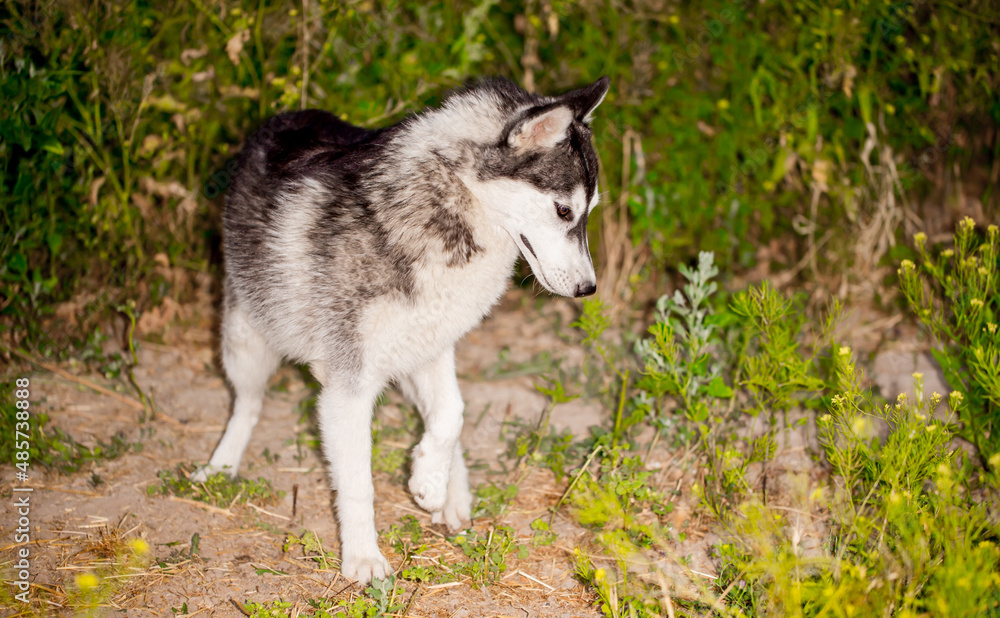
[318,381,392,583]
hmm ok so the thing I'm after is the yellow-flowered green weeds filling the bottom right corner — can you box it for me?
[718,354,1000,617]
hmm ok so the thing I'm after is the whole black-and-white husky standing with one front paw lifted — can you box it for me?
[194,77,609,583]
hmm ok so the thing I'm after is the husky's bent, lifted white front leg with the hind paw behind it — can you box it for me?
[399,348,472,529]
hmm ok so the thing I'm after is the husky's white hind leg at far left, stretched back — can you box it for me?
[191,305,281,481]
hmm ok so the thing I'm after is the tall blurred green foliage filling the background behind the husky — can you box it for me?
[0,0,1000,340]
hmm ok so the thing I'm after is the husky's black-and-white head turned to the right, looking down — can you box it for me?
[474,77,610,296]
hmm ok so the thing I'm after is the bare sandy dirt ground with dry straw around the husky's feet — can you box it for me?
[0,290,940,617]
